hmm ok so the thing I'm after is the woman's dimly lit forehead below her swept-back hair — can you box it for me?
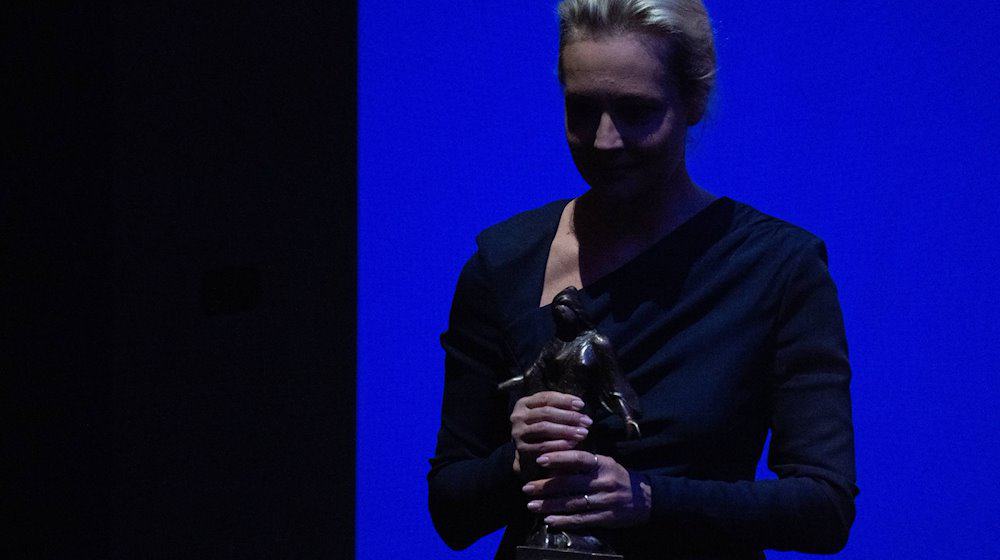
[562,33,671,95]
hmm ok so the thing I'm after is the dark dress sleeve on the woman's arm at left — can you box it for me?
[427,253,523,549]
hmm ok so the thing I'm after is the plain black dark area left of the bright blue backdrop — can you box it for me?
[2,2,356,558]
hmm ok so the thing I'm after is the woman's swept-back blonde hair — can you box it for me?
[558,0,716,124]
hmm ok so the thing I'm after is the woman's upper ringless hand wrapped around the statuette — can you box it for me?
[510,391,594,474]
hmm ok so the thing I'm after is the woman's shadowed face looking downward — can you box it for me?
[562,33,687,202]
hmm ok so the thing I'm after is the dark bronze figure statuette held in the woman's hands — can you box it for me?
[500,287,640,560]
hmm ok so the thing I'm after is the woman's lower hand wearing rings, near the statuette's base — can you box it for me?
[522,450,653,529]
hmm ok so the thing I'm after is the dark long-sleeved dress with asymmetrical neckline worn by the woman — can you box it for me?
[428,197,858,560]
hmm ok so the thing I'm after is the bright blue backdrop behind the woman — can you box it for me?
[357,0,1000,559]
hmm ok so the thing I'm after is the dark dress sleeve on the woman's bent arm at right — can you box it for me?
[632,238,857,553]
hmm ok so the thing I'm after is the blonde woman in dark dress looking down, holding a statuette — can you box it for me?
[428,0,857,559]
